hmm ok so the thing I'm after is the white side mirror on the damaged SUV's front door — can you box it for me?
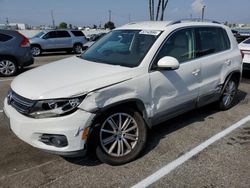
[157,56,180,70]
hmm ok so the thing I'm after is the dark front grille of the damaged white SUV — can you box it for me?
[7,90,35,114]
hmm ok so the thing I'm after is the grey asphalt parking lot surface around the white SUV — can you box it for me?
[0,53,250,188]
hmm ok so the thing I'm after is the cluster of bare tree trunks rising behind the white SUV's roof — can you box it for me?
[148,0,168,21]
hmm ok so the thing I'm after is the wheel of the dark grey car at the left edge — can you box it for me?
[0,57,18,77]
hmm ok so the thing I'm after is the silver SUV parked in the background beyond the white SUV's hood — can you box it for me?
[30,30,87,56]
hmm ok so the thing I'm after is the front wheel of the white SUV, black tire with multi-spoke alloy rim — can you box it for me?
[95,108,147,165]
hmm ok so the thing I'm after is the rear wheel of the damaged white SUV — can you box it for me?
[218,77,239,110]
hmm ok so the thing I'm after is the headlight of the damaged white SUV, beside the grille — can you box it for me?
[29,97,84,118]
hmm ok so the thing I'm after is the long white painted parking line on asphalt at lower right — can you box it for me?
[132,115,250,188]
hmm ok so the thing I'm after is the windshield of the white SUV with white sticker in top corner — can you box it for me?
[81,30,161,67]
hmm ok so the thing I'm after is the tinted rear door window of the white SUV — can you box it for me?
[198,27,230,56]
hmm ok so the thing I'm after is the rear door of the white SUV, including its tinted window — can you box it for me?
[196,26,233,105]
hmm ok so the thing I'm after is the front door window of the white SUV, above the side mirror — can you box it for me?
[156,29,196,62]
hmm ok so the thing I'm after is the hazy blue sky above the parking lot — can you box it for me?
[0,0,250,26]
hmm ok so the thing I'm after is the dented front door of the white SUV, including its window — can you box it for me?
[150,28,200,122]
